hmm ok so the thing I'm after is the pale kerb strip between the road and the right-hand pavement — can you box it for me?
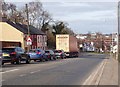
[82,59,108,85]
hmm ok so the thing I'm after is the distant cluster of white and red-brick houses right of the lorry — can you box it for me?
[76,33,115,52]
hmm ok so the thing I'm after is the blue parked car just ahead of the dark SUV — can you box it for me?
[27,49,47,61]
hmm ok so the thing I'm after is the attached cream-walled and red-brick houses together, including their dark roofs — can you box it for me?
[0,18,47,50]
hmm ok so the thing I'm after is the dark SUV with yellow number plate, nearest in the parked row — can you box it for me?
[2,47,30,64]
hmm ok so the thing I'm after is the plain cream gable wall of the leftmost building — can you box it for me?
[0,22,24,48]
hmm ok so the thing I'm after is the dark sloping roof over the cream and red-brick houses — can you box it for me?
[2,18,45,35]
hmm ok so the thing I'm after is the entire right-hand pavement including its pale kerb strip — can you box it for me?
[84,53,119,87]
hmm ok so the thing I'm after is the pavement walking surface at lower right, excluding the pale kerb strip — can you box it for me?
[99,58,118,85]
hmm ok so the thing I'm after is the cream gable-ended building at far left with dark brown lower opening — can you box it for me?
[0,18,24,48]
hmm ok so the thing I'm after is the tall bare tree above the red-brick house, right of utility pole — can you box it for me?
[22,0,51,29]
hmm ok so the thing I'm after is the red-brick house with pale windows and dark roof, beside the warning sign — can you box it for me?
[17,23,47,50]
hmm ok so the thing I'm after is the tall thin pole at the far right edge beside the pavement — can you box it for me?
[117,1,120,62]
